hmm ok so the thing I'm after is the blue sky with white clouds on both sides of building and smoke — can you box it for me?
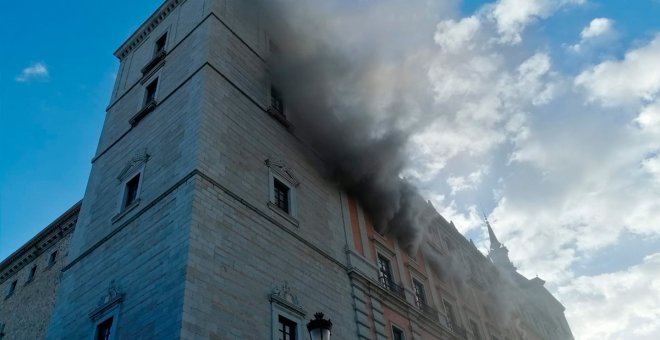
[0,0,660,339]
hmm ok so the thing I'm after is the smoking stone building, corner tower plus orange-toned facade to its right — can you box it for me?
[0,0,572,340]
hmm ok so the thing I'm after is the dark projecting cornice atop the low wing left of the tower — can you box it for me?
[0,201,82,284]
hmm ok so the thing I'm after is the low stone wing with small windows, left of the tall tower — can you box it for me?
[0,202,80,340]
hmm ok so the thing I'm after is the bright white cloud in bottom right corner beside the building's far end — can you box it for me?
[559,253,660,340]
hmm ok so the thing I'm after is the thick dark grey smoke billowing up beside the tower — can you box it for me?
[262,0,447,248]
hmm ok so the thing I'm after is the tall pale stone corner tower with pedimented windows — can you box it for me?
[48,0,357,339]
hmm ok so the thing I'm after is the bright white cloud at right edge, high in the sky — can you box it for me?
[575,35,660,105]
